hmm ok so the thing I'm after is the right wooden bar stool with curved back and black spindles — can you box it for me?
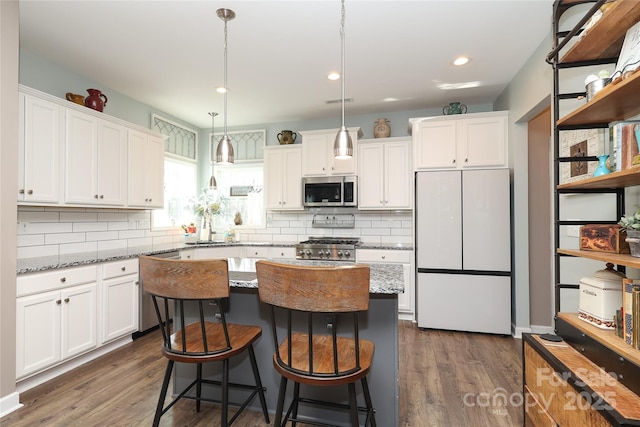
[256,261,376,427]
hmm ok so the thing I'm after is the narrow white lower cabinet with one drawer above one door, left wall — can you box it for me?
[102,258,140,343]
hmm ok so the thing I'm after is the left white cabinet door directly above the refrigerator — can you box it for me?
[413,121,457,170]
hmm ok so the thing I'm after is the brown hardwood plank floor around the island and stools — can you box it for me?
[0,321,523,427]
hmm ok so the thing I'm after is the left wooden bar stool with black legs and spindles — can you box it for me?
[140,256,269,427]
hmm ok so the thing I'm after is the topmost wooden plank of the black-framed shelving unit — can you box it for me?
[560,0,640,63]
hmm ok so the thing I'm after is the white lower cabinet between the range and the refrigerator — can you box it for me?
[356,249,415,320]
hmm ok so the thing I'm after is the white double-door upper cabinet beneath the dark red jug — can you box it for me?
[65,110,127,206]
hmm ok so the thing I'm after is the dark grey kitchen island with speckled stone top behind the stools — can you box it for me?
[172,258,404,426]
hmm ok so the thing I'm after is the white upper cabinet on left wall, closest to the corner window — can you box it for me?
[128,129,164,208]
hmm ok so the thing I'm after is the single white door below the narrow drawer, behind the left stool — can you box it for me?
[102,274,139,343]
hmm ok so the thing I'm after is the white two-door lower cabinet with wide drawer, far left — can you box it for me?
[16,267,98,379]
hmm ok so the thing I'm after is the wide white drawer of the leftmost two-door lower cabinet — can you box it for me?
[16,265,97,297]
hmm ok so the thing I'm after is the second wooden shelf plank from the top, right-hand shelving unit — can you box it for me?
[557,69,640,126]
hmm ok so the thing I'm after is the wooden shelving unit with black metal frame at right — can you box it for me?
[524,0,640,426]
